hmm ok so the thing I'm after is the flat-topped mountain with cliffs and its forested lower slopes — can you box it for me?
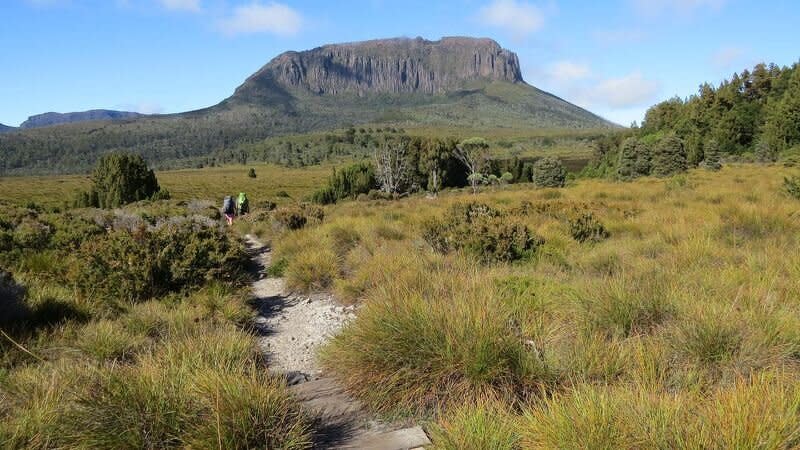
[0,37,616,174]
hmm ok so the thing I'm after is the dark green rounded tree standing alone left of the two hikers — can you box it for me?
[87,153,160,208]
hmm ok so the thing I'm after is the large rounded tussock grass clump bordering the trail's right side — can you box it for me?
[324,256,551,411]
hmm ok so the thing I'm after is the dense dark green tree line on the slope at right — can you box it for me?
[581,60,800,180]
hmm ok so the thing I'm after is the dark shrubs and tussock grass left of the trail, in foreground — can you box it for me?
[0,202,311,449]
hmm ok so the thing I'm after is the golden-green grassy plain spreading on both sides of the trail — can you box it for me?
[0,160,800,449]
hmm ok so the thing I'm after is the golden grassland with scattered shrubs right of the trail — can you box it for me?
[262,165,800,449]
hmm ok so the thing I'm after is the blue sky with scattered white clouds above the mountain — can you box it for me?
[0,0,800,125]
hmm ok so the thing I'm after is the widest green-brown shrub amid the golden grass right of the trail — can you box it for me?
[422,203,544,263]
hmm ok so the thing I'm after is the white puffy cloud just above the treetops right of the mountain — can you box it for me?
[587,71,661,108]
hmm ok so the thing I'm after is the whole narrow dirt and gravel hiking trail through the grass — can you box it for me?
[245,235,431,450]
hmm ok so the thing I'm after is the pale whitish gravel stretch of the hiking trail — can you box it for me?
[245,235,355,381]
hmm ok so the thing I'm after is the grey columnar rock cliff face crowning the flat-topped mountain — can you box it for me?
[235,37,523,97]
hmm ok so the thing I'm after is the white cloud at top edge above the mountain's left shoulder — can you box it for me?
[218,1,303,36]
